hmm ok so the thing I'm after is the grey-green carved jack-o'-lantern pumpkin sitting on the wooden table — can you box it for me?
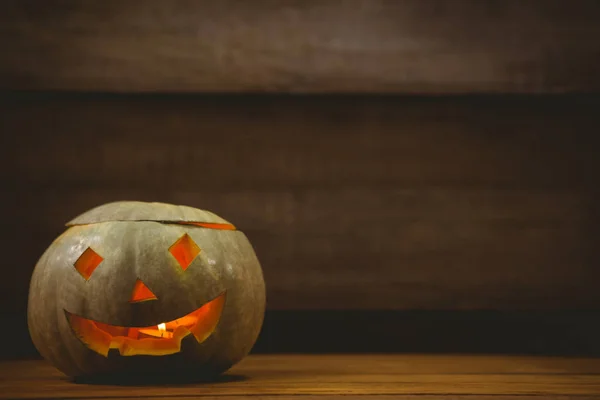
[27,202,265,377]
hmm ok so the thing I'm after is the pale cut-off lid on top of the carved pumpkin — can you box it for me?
[66,201,231,226]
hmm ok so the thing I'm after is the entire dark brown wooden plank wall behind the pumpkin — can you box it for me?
[0,0,600,356]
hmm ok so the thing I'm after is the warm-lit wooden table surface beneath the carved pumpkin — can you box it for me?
[0,355,600,400]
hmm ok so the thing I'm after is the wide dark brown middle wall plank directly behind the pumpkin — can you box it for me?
[0,95,600,310]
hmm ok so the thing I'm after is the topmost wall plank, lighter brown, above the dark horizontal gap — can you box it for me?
[0,0,600,93]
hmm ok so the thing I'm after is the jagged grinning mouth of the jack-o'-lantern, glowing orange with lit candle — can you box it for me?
[65,292,225,357]
